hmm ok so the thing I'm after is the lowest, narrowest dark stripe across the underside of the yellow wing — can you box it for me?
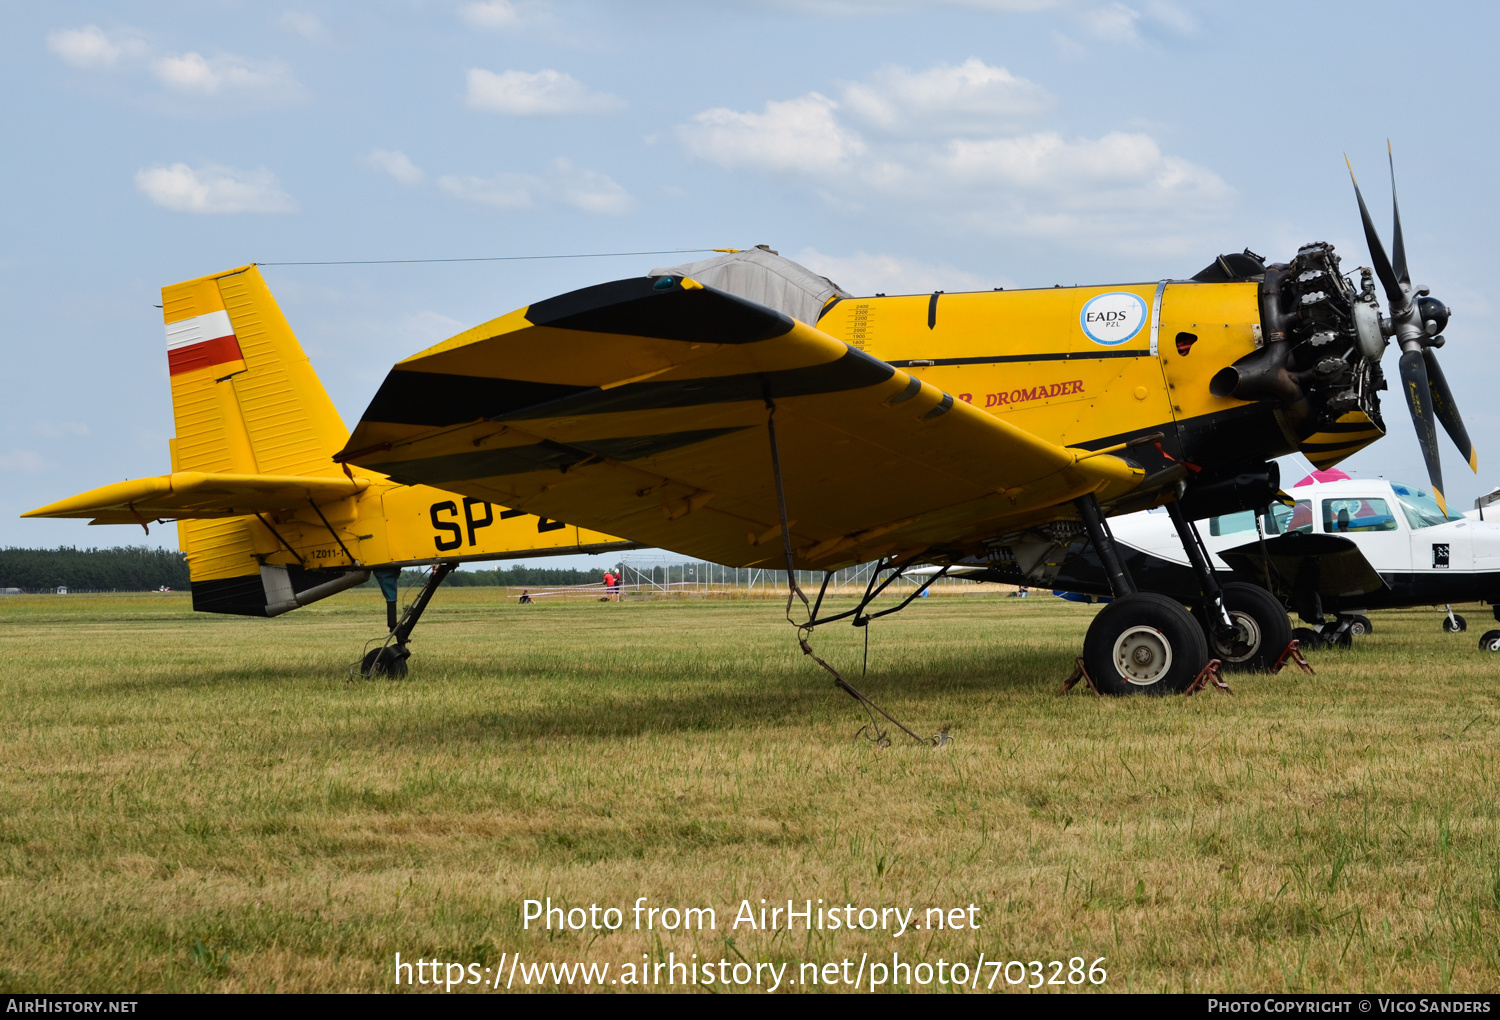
[377,426,743,485]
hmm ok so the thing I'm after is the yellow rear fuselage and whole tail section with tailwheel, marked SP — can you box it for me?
[24,266,636,674]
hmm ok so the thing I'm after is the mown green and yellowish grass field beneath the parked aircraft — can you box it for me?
[0,588,1500,992]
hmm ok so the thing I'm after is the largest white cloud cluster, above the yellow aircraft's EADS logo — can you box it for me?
[678,60,1235,255]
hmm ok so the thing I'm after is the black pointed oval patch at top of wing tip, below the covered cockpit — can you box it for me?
[527,276,792,344]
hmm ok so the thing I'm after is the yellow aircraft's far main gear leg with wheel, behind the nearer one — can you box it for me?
[1167,501,1292,672]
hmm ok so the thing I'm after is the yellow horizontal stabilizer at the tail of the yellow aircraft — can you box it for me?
[21,471,369,524]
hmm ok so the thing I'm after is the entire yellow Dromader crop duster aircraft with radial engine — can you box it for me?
[33,153,1476,696]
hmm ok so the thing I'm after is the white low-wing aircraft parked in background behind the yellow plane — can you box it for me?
[1053,470,1500,651]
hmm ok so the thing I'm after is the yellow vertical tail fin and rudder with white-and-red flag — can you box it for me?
[162,266,350,597]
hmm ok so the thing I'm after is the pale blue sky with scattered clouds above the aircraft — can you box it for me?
[0,0,1500,567]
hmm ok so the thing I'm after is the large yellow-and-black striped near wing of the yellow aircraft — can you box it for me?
[338,278,1145,570]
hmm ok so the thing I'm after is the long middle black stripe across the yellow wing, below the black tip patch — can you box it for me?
[365,348,896,428]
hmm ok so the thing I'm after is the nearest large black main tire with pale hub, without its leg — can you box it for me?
[1083,593,1209,695]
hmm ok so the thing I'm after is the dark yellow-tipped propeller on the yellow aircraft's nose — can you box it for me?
[1344,140,1479,513]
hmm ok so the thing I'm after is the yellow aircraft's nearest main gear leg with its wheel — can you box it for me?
[1074,494,1209,695]
